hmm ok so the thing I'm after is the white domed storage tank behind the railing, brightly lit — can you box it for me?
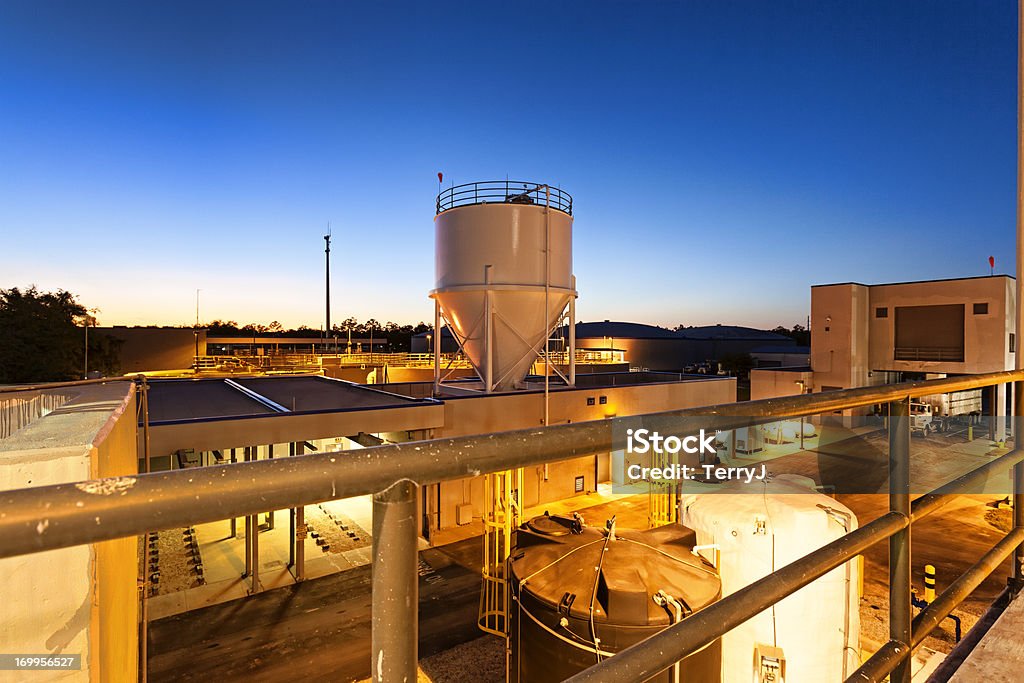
[682,475,860,683]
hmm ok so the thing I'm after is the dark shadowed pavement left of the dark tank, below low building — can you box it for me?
[148,539,482,683]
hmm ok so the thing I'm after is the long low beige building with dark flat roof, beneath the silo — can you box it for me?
[138,373,736,537]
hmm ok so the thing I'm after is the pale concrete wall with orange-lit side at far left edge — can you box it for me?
[0,382,138,681]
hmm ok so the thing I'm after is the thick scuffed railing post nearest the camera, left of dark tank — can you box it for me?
[371,479,420,683]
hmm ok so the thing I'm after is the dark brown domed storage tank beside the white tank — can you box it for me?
[508,517,721,683]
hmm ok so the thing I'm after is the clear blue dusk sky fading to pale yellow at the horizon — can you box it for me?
[0,0,1016,328]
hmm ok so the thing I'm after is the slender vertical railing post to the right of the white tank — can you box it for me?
[889,398,912,683]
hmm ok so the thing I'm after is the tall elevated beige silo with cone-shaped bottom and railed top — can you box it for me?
[431,181,575,391]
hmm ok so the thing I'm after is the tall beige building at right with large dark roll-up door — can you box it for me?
[751,275,1016,415]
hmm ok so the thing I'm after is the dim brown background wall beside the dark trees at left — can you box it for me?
[96,327,206,375]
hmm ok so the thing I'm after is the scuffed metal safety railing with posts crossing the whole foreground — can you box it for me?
[0,371,1024,683]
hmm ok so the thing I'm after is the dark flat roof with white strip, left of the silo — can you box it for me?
[150,375,425,424]
